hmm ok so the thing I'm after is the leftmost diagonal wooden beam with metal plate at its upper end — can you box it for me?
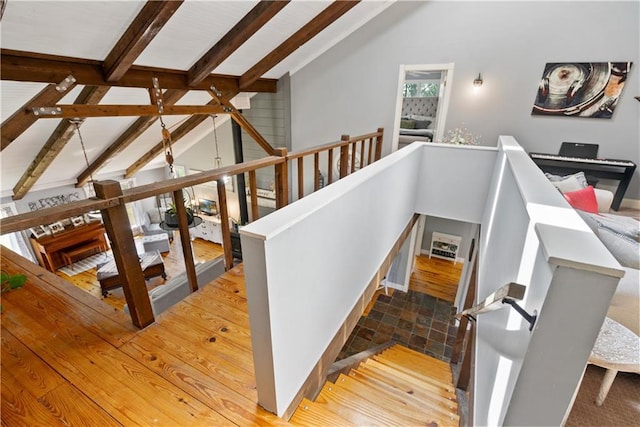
[0,76,76,151]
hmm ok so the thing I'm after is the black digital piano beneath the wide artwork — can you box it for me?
[529,153,636,211]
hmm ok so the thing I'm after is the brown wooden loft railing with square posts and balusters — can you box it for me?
[0,128,383,327]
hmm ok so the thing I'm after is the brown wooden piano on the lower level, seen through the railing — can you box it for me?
[29,221,108,272]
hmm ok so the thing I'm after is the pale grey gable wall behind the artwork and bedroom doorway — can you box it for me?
[291,1,640,199]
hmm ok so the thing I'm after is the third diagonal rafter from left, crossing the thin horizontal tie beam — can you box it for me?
[76,89,187,187]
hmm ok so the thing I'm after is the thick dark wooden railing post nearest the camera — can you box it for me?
[94,180,154,328]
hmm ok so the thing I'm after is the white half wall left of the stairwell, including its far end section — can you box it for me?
[241,144,496,414]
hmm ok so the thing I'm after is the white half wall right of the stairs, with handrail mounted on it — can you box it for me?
[473,136,623,426]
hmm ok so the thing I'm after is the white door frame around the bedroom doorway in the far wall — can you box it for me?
[391,62,454,151]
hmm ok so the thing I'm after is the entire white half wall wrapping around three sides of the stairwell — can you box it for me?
[240,137,622,425]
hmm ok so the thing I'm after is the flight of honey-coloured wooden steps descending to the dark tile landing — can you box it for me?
[289,344,459,426]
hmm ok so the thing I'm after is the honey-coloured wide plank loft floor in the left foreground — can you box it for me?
[1,246,286,426]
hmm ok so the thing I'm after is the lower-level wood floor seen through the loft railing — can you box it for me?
[56,232,223,310]
